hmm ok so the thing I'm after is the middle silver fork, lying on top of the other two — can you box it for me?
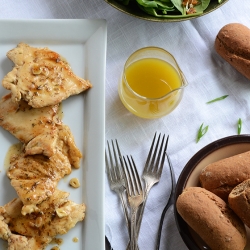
[123,156,144,250]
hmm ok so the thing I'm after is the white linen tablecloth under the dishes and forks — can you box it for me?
[0,0,250,250]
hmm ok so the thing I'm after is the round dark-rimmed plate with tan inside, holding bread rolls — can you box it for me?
[174,135,250,250]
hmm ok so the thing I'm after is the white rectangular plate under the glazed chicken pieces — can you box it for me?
[0,20,107,250]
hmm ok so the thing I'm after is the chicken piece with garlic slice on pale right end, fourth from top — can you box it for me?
[8,191,85,238]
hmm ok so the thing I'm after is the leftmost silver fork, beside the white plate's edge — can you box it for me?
[105,140,130,231]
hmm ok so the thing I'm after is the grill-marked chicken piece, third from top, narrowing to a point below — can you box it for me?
[7,152,71,215]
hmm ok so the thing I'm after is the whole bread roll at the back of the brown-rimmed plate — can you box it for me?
[200,151,250,201]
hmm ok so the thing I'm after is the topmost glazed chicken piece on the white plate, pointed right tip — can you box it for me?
[2,43,92,108]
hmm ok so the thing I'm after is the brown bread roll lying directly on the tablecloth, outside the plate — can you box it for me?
[215,23,250,79]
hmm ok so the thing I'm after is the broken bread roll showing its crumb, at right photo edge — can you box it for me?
[228,179,250,228]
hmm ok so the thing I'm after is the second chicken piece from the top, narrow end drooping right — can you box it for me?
[0,94,82,168]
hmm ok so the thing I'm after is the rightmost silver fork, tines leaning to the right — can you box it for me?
[137,133,169,235]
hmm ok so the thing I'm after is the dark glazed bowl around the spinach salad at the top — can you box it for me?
[104,0,228,22]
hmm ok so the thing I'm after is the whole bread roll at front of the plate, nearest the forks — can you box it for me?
[176,187,247,250]
